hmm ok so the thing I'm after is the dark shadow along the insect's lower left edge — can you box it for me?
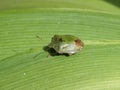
[43,46,69,56]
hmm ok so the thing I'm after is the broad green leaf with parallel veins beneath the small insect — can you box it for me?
[0,0,120,90]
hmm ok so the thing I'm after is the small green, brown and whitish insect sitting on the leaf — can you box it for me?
[48,35,84,55]
